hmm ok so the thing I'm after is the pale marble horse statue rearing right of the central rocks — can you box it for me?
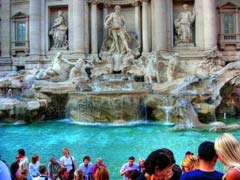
[144,54,160,84]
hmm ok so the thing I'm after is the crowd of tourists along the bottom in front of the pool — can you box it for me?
[0,133,240,180]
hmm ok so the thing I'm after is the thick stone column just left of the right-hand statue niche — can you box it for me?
[152,0,168,51]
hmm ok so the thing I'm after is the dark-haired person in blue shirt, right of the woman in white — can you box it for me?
[78,156,93,180]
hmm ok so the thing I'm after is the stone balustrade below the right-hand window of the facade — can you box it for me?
[219,33,240,50]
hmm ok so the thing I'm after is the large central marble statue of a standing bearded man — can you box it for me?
[104,6,130,54]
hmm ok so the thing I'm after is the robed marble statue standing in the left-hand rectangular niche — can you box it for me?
[49,10,68,49]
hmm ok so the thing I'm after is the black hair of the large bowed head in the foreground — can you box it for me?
[144,148,175,174]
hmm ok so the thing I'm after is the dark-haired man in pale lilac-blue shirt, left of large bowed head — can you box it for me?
[120,156,139,180]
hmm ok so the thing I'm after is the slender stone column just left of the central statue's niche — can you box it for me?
[91,0,98,54]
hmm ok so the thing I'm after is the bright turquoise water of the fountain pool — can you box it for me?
[0,120,240,180]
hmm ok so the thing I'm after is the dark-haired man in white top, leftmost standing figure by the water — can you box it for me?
[18,149,28,180]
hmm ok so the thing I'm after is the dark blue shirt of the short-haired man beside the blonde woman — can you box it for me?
[180,169,223,180]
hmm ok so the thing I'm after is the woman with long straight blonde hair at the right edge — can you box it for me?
[215,133,240,180]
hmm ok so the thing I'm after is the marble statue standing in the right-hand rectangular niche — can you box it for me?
[174,4,195,44]
